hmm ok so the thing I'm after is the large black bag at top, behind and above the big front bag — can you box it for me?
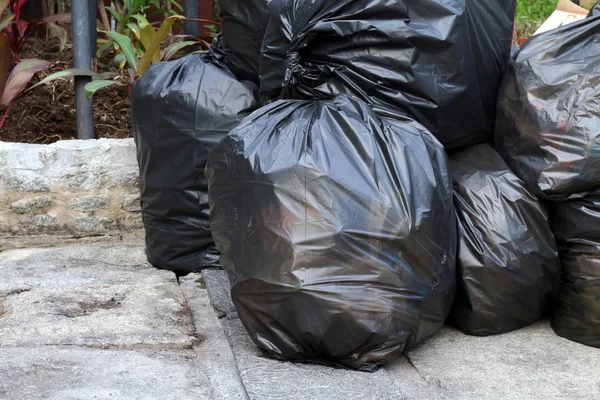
[253,0,515,149]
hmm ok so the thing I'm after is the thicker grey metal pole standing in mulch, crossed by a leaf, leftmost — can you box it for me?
[71,0,96,139]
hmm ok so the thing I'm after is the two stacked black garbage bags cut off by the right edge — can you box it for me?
[495,8,600,347]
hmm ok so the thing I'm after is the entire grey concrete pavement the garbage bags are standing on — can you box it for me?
[0,241,600,400]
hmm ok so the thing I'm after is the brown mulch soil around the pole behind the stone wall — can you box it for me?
[0,38,132,144]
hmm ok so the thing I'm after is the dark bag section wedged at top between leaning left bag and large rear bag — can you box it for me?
[219,0,269,83]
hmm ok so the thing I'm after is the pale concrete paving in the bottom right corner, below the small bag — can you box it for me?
[404,321,600,400]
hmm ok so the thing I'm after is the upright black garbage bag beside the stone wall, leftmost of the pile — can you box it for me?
[131,49,258,274]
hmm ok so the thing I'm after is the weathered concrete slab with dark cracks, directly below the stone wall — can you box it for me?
[0,243,201,348]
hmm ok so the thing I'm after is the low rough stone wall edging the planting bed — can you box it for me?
[0,139,142,236]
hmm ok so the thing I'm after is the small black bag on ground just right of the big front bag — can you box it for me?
[449,144,561,336]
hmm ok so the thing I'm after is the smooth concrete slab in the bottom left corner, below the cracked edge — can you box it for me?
[0,346,213,400]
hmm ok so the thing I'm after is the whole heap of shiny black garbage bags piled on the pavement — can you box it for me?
[132,0,600,371]
